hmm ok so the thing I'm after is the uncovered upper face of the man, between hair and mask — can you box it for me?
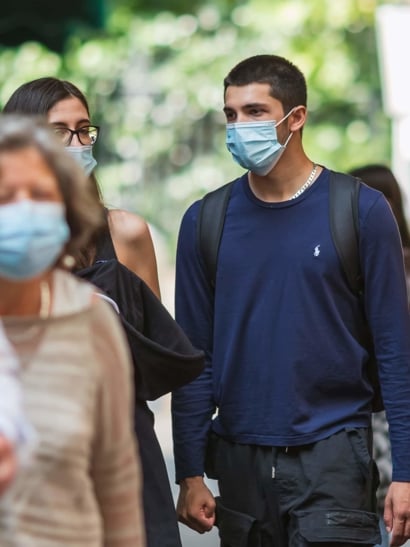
[224,83,287,123]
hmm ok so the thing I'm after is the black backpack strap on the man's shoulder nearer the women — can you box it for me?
[197,181,233,287]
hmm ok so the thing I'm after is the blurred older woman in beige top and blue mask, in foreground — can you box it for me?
[0,115,145,547]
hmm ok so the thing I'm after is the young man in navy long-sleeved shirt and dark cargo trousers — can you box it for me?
[172,55,410,547]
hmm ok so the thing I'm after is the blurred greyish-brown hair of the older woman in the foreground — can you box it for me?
[0,114,104,257]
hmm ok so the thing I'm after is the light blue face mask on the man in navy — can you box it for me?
[226,109,293,176]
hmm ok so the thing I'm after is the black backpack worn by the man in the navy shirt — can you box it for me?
[197,171,384,412]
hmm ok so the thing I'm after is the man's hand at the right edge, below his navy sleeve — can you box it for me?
[384,482,410,547]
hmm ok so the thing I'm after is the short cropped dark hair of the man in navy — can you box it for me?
[224,55,307,113]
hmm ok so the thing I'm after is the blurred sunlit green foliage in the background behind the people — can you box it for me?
[0,0,398,254]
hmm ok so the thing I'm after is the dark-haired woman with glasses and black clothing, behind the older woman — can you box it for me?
[4,77,202,547]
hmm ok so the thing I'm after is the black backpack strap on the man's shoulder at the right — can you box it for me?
[329,171,363,294]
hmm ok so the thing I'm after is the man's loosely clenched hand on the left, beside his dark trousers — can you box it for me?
[177,477,215,534]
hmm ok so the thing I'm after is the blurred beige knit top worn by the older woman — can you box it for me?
[0,270,145,547]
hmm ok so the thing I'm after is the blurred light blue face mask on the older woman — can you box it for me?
[0,200,70,281]
